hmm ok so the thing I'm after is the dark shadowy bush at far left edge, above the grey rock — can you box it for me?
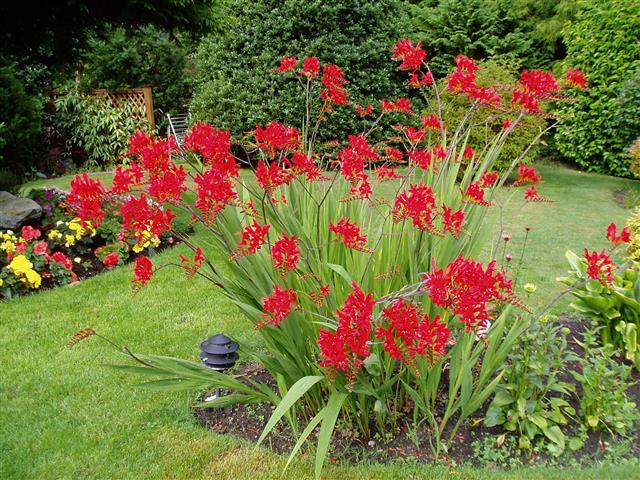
[0,66,43,175]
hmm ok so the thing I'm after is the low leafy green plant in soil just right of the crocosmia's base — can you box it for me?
[484,318,576,455]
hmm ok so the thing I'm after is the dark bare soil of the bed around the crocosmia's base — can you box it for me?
[195,315,640,466]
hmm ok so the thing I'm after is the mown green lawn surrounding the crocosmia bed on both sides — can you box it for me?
[5,166,640,479]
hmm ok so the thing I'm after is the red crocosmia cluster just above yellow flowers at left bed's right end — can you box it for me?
[120,193,176,245]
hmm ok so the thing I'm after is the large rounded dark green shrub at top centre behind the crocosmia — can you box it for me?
[191,0,408,142]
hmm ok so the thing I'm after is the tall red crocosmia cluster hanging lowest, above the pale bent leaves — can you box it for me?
[318,282,375,390]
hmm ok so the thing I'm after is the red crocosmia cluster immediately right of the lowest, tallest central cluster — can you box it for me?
[376,299,450,375]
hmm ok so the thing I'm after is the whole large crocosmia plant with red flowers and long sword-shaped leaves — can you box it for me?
[69,40,577,475]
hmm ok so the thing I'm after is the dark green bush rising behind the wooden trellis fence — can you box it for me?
[81,26,191,124]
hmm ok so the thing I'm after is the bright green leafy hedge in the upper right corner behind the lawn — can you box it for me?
[556,0,640,176]
